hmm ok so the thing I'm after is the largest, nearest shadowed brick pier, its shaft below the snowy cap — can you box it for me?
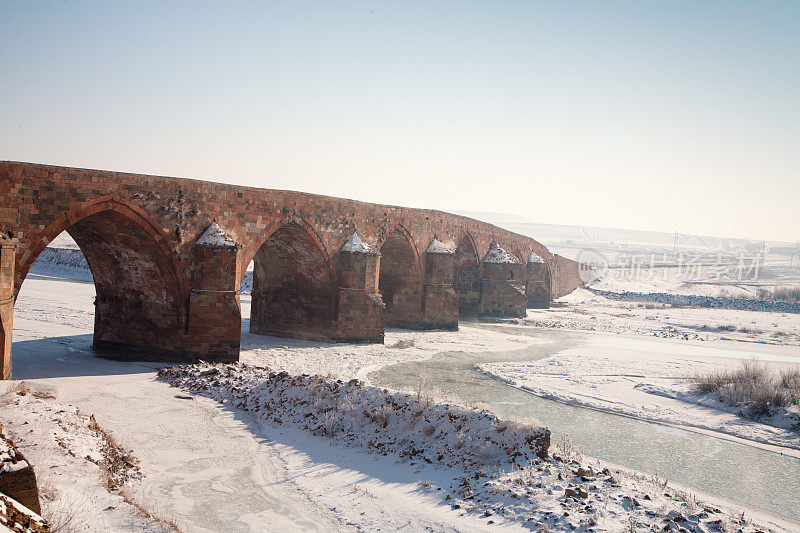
[186,245,242,362]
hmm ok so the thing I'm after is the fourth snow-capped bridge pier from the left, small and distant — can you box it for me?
[481,244,528,318]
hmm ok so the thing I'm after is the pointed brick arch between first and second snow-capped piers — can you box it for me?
[250,219,337,340]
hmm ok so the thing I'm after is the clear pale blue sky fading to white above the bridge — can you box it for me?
[0,0,800,241]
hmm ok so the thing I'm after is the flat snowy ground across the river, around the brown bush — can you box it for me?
[481,264,800,456]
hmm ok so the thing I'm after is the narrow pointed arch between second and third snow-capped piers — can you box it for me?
[378,224,422,327]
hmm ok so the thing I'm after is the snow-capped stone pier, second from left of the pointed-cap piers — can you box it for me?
[333,233,386,343]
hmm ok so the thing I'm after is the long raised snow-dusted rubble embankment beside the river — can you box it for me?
[159,363,550,469]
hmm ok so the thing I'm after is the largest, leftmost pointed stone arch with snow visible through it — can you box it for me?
[15,196,188,359]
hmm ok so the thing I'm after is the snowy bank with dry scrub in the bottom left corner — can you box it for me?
[0,382,175,532]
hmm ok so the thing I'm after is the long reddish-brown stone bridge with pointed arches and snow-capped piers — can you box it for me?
[0,161,580,379]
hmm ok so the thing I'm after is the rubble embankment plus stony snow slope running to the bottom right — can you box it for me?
[159,364,780,531]
